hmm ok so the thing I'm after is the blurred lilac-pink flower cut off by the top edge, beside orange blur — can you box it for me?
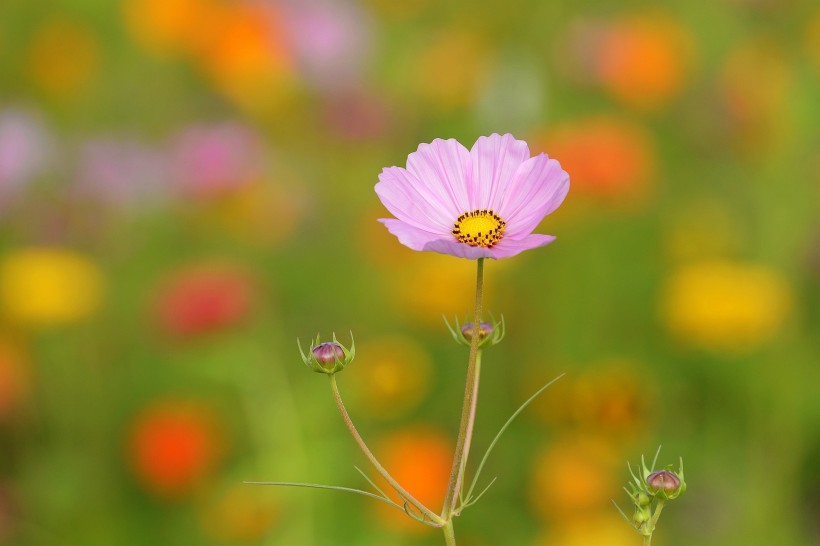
[283,0,372,89]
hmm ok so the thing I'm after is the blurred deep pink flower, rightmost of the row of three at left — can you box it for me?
[171,123,263,197]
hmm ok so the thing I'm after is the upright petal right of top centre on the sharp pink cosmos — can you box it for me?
[470,133,530,210]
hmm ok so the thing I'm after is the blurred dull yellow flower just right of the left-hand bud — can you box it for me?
[345,336,432,419]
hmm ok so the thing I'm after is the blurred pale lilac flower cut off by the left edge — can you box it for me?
[0,110,51,200]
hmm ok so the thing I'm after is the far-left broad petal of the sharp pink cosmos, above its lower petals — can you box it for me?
[376,167,459,234]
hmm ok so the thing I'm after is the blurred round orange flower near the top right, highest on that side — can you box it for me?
[597,14,693,110]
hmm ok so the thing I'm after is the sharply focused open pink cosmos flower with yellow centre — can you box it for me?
[376,134,569,259]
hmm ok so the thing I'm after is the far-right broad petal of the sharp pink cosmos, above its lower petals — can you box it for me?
[497,154,569,239]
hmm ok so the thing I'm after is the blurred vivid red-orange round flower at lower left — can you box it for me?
[127,400,225,498]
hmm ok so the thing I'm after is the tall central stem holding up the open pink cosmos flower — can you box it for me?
[441,258,484,522]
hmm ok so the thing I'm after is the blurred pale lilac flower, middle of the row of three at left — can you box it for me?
[76,138,168,205]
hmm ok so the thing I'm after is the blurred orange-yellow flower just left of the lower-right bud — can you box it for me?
[530,436,623,523]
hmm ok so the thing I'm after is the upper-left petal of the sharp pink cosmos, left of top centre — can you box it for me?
[407,138,472,215]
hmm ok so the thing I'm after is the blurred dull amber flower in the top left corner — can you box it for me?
[28,19,100,97]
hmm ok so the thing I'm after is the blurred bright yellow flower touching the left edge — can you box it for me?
[0,247,103,326]
